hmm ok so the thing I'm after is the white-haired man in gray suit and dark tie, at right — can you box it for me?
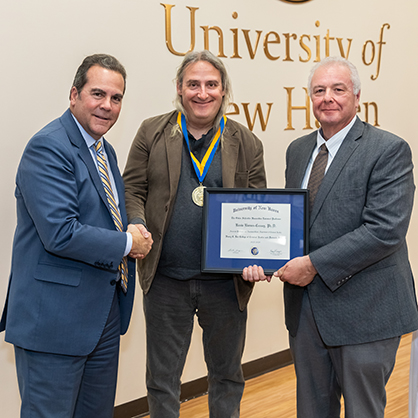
[243,58,418,418]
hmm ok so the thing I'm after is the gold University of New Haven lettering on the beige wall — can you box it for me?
[160,3,390,131]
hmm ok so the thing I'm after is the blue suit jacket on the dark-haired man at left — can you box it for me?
[0,110,135,355]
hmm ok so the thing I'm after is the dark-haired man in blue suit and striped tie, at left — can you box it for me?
[0,54,152,418]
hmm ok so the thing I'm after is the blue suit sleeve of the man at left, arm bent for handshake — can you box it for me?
[16,135,126,270]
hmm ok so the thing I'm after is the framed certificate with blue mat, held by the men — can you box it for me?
[202,187,309,274]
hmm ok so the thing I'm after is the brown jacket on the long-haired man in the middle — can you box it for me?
[123,111,266,309]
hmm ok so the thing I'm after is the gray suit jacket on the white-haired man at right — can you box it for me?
[285,119,418,346]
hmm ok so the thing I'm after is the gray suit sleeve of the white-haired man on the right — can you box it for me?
[310,138,415,291]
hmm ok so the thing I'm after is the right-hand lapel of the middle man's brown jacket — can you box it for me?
[221,120,239,188]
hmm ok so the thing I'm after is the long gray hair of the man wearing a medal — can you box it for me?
[174,50,232,125]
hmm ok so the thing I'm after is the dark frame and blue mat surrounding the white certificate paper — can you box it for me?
[201,187,309,275]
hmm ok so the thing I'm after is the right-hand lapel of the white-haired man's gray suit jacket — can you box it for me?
[310,119,364,225]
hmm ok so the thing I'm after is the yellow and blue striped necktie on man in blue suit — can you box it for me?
[95,141,128,293]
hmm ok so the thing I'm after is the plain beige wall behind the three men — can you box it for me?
[0,0,418,417]
